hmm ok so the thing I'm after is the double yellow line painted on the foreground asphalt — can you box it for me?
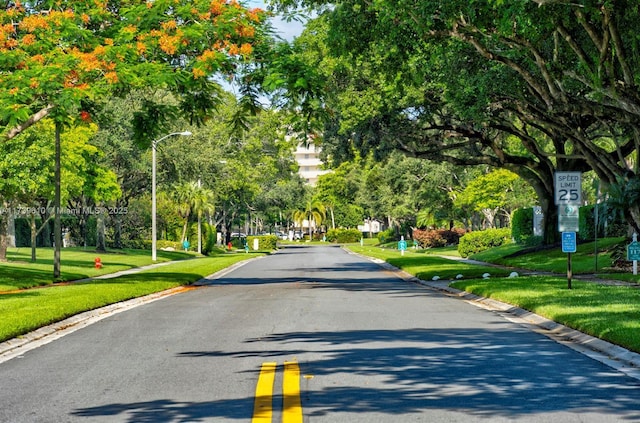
[251,361,302,423]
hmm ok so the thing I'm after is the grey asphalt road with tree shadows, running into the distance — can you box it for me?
[0,247,640,423]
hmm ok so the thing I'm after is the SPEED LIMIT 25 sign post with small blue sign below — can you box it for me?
[554,172,582,289]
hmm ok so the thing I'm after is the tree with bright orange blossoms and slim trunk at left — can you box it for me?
[0,0,265,278]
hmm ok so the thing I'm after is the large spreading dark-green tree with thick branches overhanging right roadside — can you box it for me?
[278,0,640,242]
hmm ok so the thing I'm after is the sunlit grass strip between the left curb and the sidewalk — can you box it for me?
[0,254,255,342]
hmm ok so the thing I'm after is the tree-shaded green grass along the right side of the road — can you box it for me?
[349,239,640,353]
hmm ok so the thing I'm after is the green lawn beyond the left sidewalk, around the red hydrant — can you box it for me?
[0,248,195,292]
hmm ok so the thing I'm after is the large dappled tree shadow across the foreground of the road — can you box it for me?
[74,325,640,422]
